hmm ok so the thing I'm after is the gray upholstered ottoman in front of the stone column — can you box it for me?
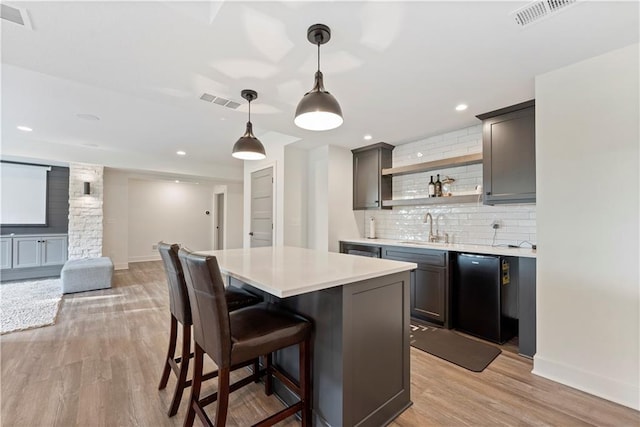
[60,257,113,294]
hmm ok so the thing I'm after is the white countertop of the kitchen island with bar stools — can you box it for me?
[198,246,418,298]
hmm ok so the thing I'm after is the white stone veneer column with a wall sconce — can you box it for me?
[69,163,104,259]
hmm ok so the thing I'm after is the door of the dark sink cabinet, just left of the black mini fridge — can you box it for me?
[411,266,446,323]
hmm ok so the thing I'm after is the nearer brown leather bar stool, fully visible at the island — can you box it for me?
[179,249,312,427]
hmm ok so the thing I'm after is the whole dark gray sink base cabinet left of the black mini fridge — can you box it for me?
[382,247,450,327]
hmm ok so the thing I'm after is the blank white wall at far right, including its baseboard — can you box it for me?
[534,45,640,409]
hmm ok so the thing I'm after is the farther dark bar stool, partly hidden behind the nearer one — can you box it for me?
[158,242,262,417]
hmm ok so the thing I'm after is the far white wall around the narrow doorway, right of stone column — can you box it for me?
[103,168,243,269]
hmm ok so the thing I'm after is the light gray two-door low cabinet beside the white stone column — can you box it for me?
[9,235,67,269]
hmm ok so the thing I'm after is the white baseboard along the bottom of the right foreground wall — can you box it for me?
[531,354,640,410]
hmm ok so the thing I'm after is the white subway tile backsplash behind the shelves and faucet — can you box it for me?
[361,124,536,246]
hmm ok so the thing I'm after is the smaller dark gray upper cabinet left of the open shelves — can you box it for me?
[351,142,395,210]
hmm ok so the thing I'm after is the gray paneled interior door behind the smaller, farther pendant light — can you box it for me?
[249,167,273,248]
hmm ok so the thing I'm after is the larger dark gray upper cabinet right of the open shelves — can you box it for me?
[476,100,536,205]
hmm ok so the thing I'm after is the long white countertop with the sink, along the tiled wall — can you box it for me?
[342,238,536,258]
